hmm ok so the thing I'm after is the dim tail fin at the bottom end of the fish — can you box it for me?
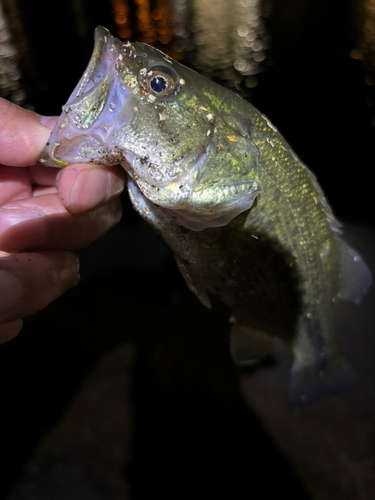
[287,354,358,408]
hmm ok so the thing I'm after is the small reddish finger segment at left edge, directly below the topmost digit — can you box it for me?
[0,165,32,206]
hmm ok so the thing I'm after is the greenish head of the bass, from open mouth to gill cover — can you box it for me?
[44,27,261,230]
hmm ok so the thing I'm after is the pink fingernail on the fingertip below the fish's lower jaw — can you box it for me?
[70,168,111,212]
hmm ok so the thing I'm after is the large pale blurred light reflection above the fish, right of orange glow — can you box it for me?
[171,0,268,95]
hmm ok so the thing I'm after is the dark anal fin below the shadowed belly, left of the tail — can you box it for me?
[230,317,274,366]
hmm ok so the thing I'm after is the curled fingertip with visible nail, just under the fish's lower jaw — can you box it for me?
[57,163,125,214]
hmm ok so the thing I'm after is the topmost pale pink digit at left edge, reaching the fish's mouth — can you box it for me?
[0,98,51,167]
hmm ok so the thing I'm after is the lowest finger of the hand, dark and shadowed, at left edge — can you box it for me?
[0,251,79,328]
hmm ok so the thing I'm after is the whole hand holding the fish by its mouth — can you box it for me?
[0,98,125,344]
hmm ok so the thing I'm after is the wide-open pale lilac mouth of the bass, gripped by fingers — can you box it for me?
[41,26,139,167]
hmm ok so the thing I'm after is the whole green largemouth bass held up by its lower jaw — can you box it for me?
[41,26,371,407]
